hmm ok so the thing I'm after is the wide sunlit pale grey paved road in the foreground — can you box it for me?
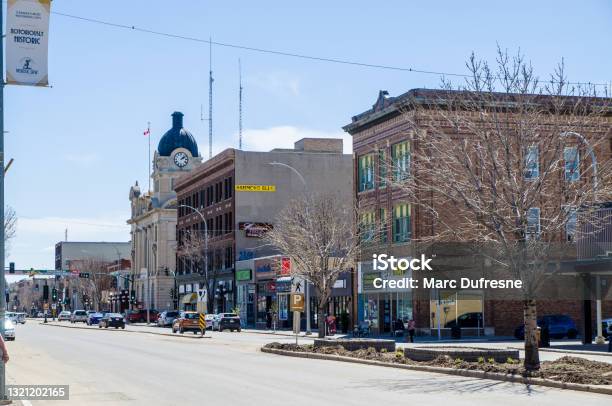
[7,323,610,406]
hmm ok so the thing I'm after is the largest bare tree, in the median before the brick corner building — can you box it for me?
[394,49,612,370]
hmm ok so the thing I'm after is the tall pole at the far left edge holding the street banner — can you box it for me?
[0,4,7,400]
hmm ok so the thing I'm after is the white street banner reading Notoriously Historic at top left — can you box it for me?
[6,0,51,86]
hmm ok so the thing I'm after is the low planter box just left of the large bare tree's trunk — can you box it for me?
[404,347,519,362]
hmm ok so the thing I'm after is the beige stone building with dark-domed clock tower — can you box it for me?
[128,112,202,311]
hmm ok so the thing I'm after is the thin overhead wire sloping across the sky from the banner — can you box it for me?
[51,11,610,87]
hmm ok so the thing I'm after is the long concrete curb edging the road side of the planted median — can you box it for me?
[261,347,612,395]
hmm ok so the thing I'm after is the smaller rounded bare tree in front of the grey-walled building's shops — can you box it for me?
[264,194,359,337]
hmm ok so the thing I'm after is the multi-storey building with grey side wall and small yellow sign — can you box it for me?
[175,138,353,327]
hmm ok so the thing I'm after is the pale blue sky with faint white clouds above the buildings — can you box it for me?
[3,0,612,269]
